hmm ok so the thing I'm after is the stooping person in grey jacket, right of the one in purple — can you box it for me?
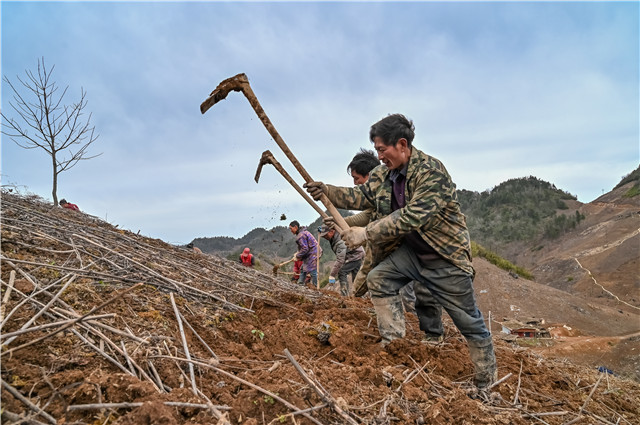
[318,224,364,297]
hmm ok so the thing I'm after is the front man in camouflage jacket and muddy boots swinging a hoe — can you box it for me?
[305,114,497,390]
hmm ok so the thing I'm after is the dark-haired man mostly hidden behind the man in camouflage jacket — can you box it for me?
[342,149,444,344]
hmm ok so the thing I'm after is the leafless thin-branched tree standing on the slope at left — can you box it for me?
[2,58,101,205]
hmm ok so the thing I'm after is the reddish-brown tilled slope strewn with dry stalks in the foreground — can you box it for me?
[1,193,640,425]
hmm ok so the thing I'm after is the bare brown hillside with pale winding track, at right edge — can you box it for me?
[494,169,640,312]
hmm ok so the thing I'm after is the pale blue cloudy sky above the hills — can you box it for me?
[0,1,640,244]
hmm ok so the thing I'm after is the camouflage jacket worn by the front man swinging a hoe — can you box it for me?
[327,146,474,274]
